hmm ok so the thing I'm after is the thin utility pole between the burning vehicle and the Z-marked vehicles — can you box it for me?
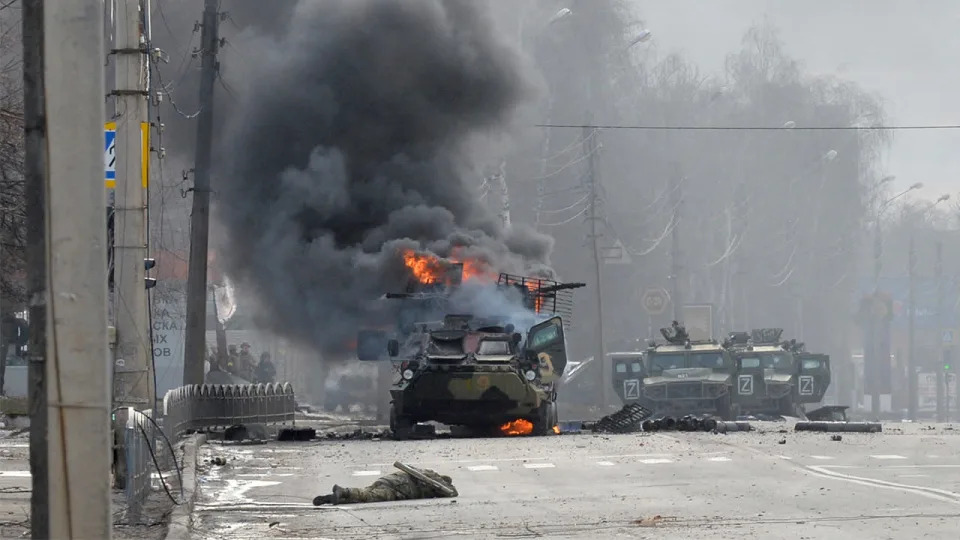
[583,122,612,409]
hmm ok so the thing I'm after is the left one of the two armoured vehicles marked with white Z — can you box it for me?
[612,321,736,419]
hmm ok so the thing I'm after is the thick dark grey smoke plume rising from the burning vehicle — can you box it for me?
[217,0,552,349]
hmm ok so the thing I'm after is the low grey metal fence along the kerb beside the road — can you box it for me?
[122,383,296,521]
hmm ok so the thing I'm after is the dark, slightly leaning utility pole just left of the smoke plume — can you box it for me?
[183,0,220,385]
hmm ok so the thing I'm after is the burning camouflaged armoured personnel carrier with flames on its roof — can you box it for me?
[367,258,584,438]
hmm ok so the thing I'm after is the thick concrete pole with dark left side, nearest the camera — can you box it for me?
[23,0,112,539]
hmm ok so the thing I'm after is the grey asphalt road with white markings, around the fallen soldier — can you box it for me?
[194,423,960,540]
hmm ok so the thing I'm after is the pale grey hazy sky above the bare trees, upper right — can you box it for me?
[633,0,960,198]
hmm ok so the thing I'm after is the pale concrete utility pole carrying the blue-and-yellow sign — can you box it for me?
[111,0,155,409]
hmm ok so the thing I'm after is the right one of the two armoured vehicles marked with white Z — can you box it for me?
[723,328,830,418]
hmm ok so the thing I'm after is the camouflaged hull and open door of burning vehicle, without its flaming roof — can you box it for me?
[390,316,567,435]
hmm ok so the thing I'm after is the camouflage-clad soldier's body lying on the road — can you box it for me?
[313,469,457,506]
